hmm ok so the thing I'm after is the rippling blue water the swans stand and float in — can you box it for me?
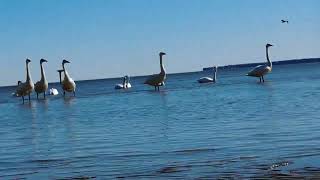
[0,64,320,179]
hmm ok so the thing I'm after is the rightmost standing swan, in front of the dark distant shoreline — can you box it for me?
[247,43,273,82]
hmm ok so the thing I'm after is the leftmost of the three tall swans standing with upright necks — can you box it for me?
[16,59,34,103]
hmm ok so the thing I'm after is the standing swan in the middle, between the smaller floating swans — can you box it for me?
[144,52,166,91]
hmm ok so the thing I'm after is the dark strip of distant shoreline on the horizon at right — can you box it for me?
[203,58,320,71]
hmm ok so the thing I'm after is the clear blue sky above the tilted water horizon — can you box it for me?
[0,0,320,86]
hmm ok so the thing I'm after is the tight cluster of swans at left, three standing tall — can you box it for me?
[15,59,76,103]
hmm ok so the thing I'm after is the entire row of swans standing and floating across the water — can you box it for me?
[15,43,273,102]
